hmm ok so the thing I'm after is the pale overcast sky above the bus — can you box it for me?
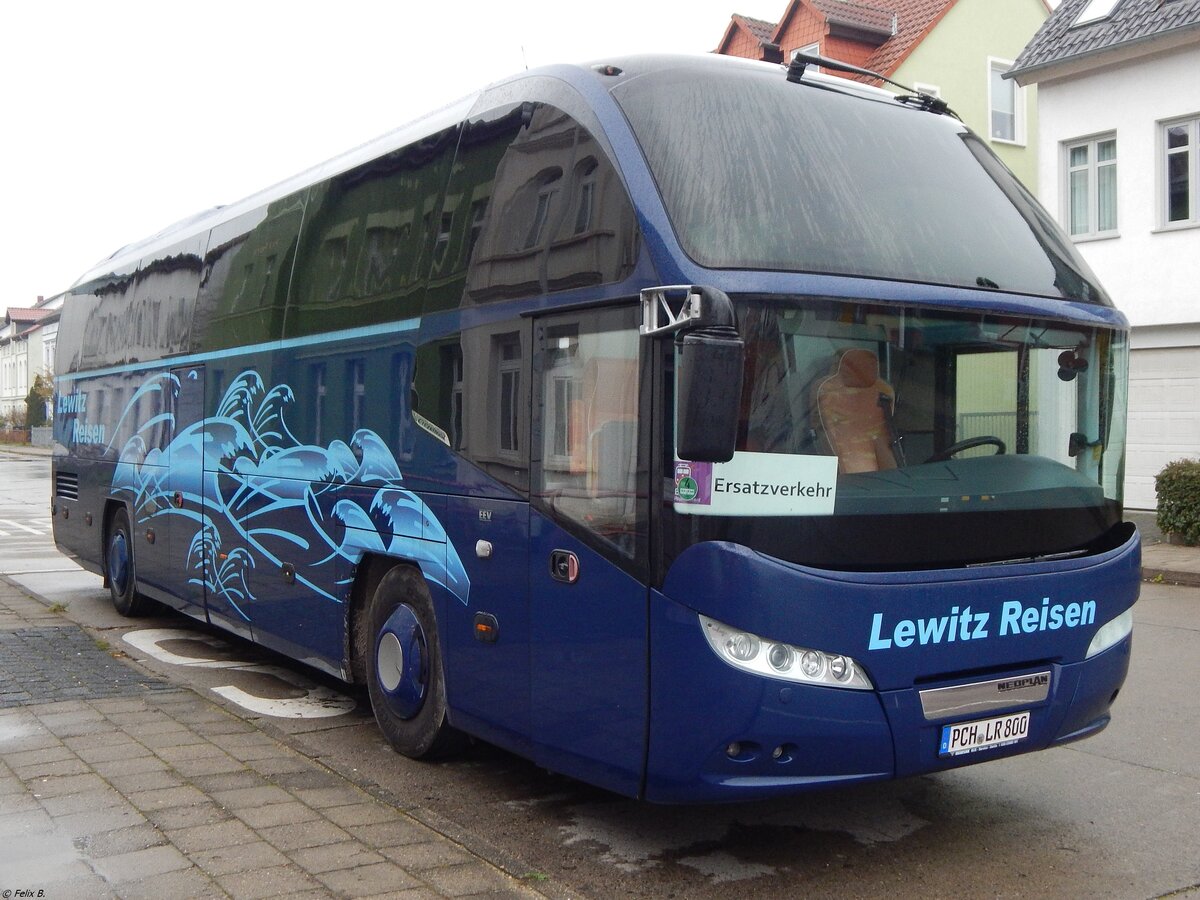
[0,0,786,308]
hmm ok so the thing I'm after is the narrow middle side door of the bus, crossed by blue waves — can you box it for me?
[167,366,204,618]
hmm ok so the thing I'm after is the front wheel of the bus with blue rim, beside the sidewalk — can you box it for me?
[366,566,466,760]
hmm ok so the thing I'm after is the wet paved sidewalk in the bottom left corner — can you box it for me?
[0,580,541,900]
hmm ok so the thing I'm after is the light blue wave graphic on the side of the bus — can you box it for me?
[113,371,470,620]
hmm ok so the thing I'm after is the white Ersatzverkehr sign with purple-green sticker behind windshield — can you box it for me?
[674,452,838,516]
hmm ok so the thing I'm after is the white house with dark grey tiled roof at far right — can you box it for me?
[1012,0,1200,509]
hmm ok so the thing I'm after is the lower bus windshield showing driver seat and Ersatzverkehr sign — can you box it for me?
[673,296,1127,569]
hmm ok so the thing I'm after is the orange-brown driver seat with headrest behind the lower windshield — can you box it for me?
[814,349,896,475]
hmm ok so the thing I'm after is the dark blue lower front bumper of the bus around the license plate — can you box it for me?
[644,594,1132,803]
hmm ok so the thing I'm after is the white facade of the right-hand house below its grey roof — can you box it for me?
[1038,44,1200,509]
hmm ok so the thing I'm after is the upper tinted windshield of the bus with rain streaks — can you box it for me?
[614,66,1111,305]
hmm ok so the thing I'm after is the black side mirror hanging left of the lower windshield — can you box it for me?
[676,330,745,462]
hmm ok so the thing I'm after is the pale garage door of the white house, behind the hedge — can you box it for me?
[1124,347,1200,509]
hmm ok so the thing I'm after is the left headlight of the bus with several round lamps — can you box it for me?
[700,616,873,691]
